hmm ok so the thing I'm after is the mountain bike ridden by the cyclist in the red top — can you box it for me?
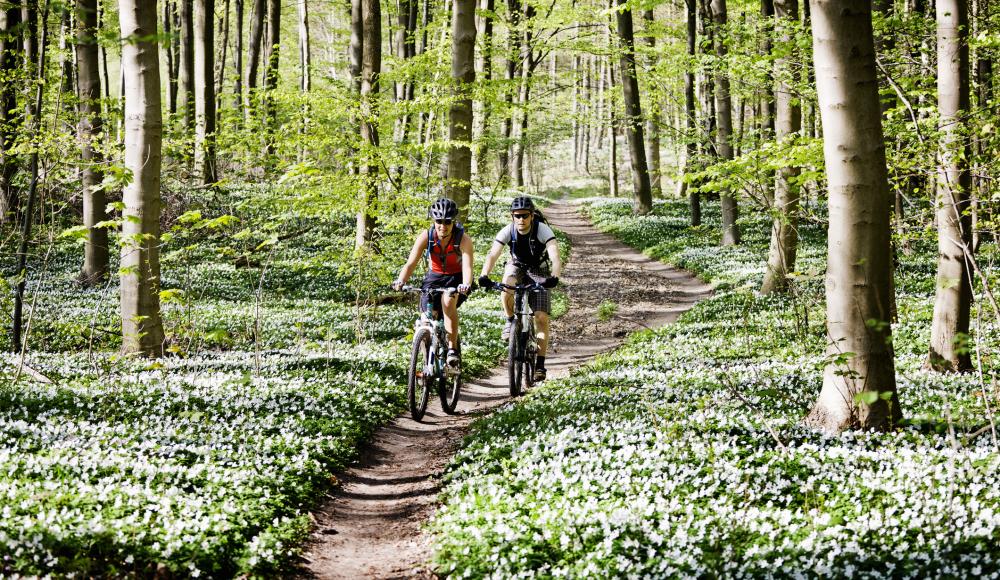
[401,286,462,421]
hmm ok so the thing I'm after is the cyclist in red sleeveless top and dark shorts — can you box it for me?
[392,198,472,368]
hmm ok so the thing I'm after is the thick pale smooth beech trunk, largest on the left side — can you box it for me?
[118,0,164,356]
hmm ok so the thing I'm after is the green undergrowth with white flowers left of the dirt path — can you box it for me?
[0,185,556,577]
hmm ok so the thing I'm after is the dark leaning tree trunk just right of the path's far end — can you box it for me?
[618,0,653,215]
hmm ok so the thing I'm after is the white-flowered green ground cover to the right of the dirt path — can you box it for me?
[431,201,1000,578]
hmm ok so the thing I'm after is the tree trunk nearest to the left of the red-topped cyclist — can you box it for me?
[354,0,382,248]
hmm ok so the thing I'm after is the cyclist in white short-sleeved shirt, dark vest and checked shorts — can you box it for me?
[479,196,562,381]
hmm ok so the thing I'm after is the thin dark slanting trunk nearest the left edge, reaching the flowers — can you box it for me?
[11,0,48,352]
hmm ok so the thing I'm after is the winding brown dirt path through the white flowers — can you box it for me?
[304,202,711,578]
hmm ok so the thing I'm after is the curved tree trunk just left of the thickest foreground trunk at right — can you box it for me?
[760,0,802,294]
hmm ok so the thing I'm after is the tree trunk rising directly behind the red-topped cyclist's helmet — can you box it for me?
[446,0,476,222]
